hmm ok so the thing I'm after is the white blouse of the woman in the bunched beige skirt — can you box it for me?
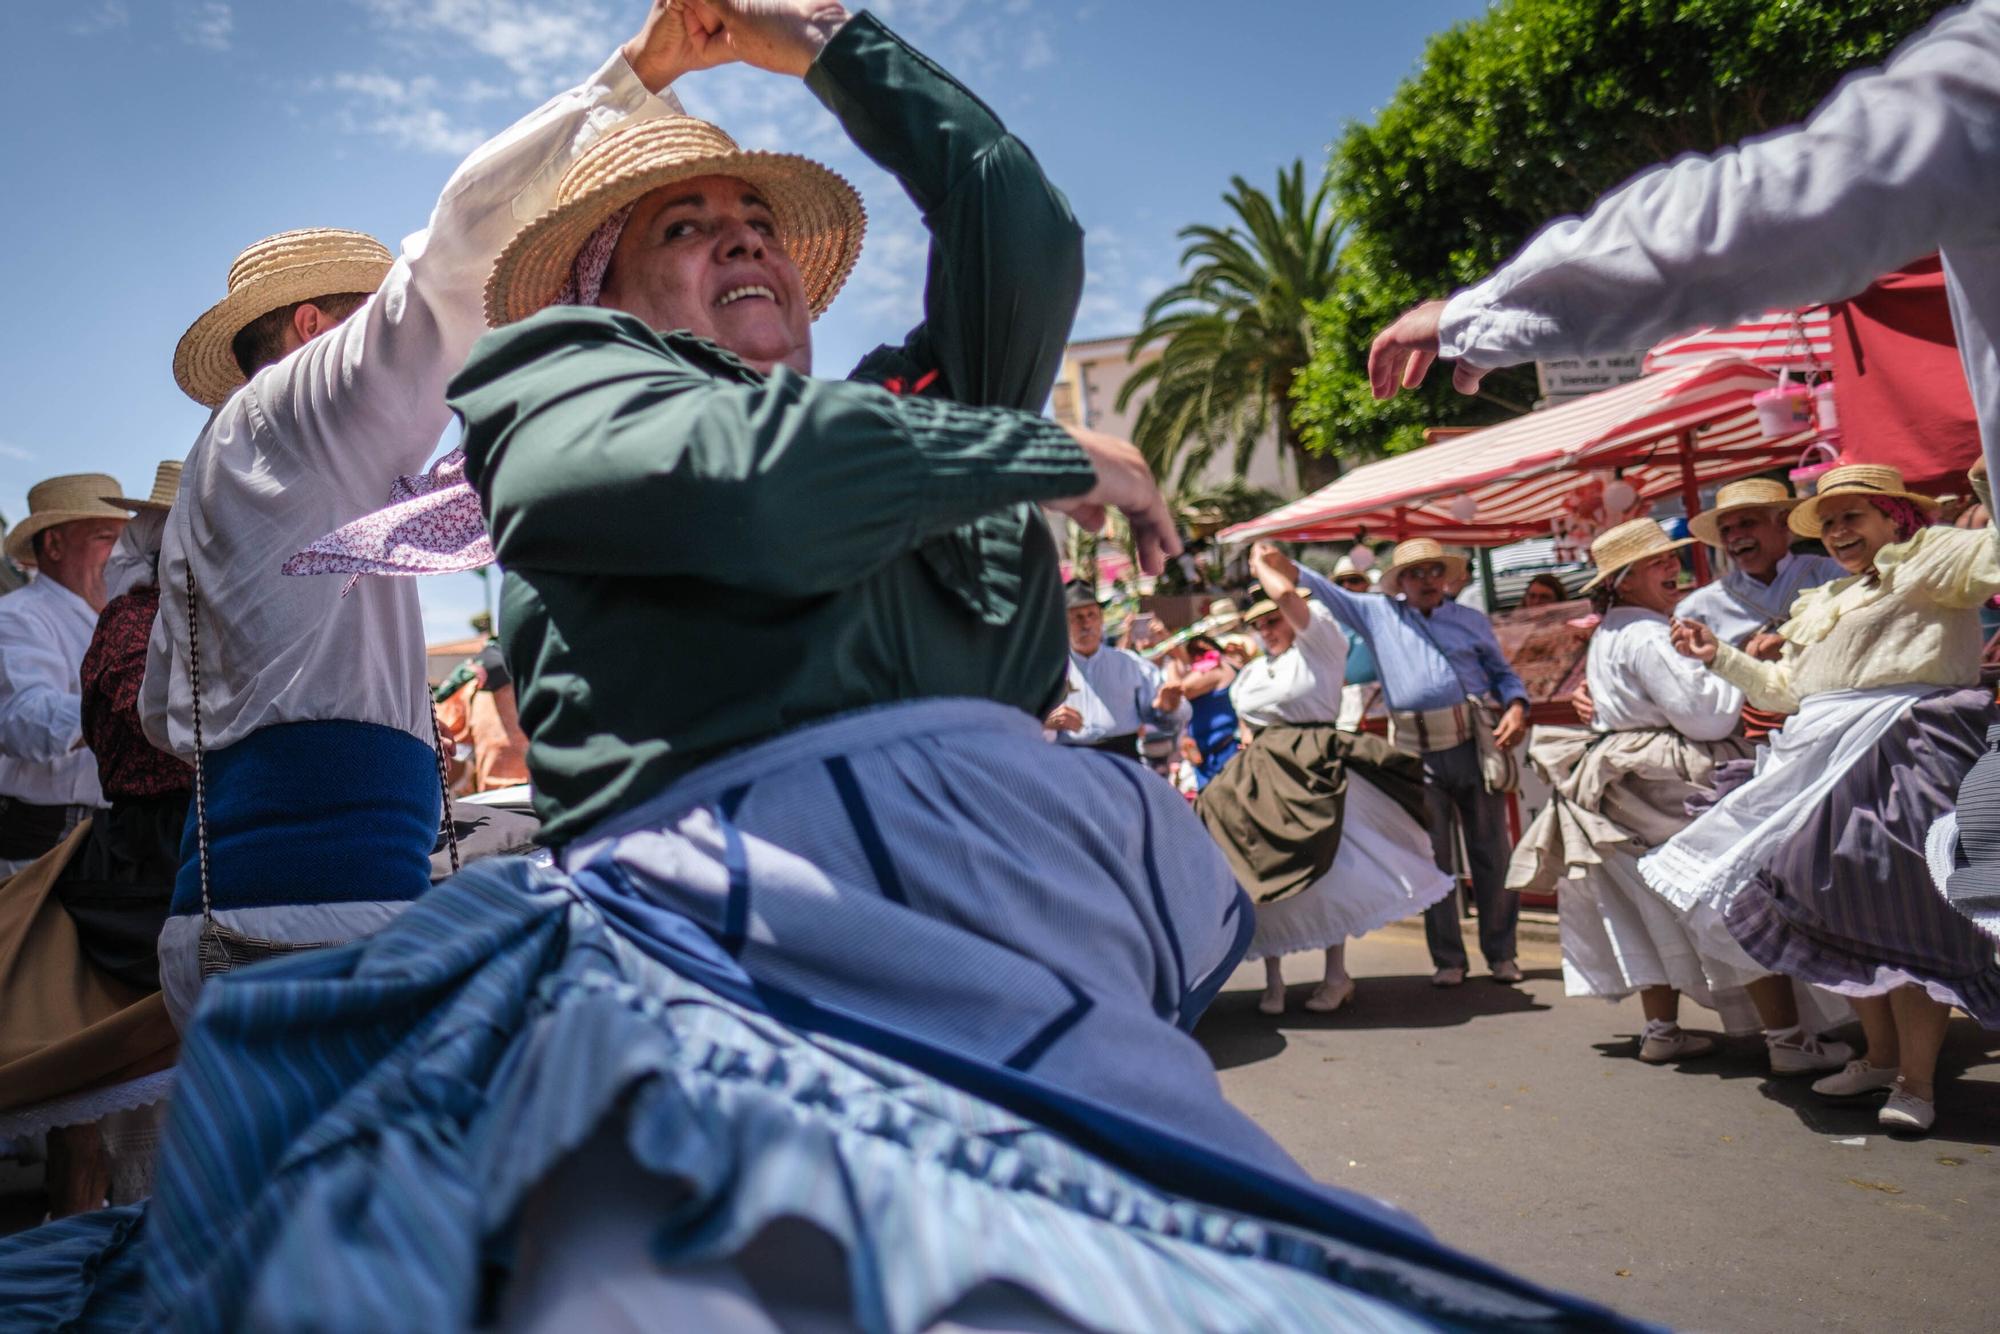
[1588,606,1744,742]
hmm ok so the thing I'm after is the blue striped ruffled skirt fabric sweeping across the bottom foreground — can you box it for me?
[0,860,1636,1332]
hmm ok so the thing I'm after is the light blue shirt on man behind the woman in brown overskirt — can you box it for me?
[1298,566,1528,712]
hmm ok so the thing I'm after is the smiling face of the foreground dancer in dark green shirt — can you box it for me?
[600,176,812,374]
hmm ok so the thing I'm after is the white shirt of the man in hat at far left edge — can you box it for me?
[0,576,104,806]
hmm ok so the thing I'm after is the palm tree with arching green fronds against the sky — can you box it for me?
[1118,162,1344,490]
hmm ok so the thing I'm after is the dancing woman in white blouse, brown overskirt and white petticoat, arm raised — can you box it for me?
[1196,556,1452,1014]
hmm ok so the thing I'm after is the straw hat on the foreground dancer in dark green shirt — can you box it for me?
[486,116,868,328]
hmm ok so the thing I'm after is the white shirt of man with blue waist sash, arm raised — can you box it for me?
[140,56,678,758]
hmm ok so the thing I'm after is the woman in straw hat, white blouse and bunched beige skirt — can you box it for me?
[1508,518,1764,1064]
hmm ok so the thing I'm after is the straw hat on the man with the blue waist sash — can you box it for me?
[174,226,396,408]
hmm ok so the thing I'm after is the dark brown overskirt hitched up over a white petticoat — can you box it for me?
[1194,722,1430,904]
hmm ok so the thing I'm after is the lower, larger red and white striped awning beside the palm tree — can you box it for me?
[1220,356,1812,546]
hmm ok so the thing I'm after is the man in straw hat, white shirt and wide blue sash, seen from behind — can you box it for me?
[140,2,704,1016]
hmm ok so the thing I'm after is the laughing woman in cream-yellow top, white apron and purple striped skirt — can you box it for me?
[1640,464,2000,1134]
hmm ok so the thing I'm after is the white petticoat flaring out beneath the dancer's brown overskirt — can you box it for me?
[1244,768,1452,960]
